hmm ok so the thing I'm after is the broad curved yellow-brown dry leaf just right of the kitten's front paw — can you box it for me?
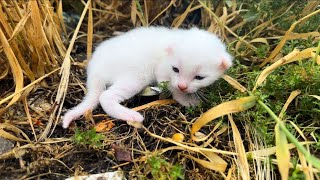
[191,96,257,141]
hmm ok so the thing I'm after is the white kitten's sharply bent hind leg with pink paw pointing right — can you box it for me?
[99,78,146,122]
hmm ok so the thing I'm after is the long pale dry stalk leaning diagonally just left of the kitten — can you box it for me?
[39,0,91,141]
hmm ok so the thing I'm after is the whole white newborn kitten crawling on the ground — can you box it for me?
[63,27,232,128]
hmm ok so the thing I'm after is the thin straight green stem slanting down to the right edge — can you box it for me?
[248,91,320,170]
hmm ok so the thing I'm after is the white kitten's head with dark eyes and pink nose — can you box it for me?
[166,28,232,93]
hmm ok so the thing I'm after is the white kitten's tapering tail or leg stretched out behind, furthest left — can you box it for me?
[62,78,105,128]
